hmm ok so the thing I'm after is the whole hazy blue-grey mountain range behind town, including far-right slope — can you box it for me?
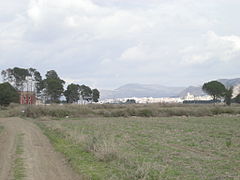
[100,78,240,100]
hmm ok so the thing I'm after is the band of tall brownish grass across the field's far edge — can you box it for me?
[1,104,240,118]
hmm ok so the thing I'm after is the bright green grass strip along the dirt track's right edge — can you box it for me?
[37,122,118,180]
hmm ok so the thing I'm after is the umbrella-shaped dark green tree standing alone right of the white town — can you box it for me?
[202,81,226,102]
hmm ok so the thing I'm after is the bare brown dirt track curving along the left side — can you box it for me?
[0,118,81,180]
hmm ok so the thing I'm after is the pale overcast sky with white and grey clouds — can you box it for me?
[0,0,240,89]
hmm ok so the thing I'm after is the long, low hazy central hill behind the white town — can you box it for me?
[100,84,185,99]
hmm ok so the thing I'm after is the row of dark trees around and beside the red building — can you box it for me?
[0,67,100,105]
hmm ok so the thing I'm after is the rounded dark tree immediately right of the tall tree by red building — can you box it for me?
[64,84,80,103]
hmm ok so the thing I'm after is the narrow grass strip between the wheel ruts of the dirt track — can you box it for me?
[13,134,25,180]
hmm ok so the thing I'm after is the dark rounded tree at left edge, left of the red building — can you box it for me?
[0,82,19,106]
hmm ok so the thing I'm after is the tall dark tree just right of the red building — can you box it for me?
[43,70,65,103]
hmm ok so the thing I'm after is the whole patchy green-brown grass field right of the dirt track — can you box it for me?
[36,116,240,180]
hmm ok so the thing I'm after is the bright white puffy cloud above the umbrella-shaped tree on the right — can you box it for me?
[180,31,240,64]
